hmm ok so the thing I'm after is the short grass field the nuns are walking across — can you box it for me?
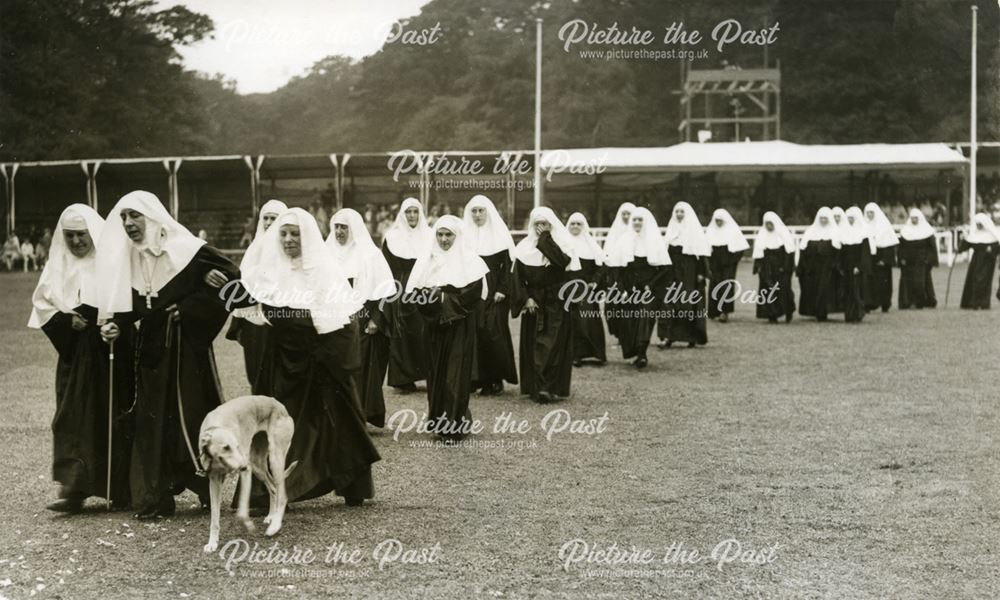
[0,263,1000,599]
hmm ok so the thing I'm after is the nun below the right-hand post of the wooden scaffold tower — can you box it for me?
[753,211,795,323]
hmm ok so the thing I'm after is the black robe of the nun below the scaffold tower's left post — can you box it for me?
[656,246,710,345]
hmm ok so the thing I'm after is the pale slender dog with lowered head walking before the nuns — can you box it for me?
[198,396,296,552]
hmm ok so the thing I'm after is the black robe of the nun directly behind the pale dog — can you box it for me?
[264,306,379,502]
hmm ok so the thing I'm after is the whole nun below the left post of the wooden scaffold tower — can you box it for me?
[657,202,712,348]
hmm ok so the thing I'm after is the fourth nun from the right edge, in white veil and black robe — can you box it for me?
[840,206,875,323]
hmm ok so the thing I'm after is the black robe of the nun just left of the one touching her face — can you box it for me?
[472,250,517,388]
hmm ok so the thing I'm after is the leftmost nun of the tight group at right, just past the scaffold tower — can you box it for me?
[795,206,840,322]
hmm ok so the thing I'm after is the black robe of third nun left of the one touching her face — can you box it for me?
[382,243,427,387]
